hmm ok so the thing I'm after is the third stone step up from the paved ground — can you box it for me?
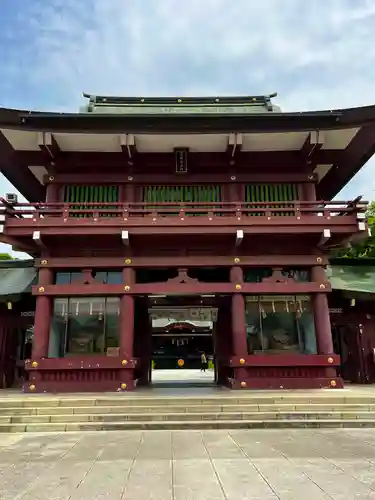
[0,402,375,416]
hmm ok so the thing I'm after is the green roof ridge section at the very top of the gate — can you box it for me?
[81,94,280,115]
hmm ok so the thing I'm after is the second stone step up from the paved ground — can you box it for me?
[0,412,375,425]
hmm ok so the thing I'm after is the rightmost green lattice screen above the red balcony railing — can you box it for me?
[245,184,299,215]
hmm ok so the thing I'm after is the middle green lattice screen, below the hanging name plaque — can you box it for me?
[143,185,221,214]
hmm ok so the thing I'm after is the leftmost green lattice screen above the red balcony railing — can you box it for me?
[64,185,119,217]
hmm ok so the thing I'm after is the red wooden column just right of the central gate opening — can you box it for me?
[230,266,247,381]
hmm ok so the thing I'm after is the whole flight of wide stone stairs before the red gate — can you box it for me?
[0,391,375,432]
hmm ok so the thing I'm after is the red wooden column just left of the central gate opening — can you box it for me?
[120,267,135,359]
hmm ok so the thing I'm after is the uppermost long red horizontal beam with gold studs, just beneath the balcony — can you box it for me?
[35,255,328,269]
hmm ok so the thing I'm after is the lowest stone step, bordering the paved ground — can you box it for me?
[0,419,375,433]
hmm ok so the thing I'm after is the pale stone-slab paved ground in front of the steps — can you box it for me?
[0,429,375,500]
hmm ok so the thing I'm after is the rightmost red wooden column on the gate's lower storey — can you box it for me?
[311,266,334,354]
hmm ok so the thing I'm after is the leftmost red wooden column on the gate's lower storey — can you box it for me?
[32,269,53,358]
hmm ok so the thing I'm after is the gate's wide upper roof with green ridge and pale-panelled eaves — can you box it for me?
[0,94,375,202]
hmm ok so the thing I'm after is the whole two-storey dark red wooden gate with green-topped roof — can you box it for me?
[0,94,375,392]
